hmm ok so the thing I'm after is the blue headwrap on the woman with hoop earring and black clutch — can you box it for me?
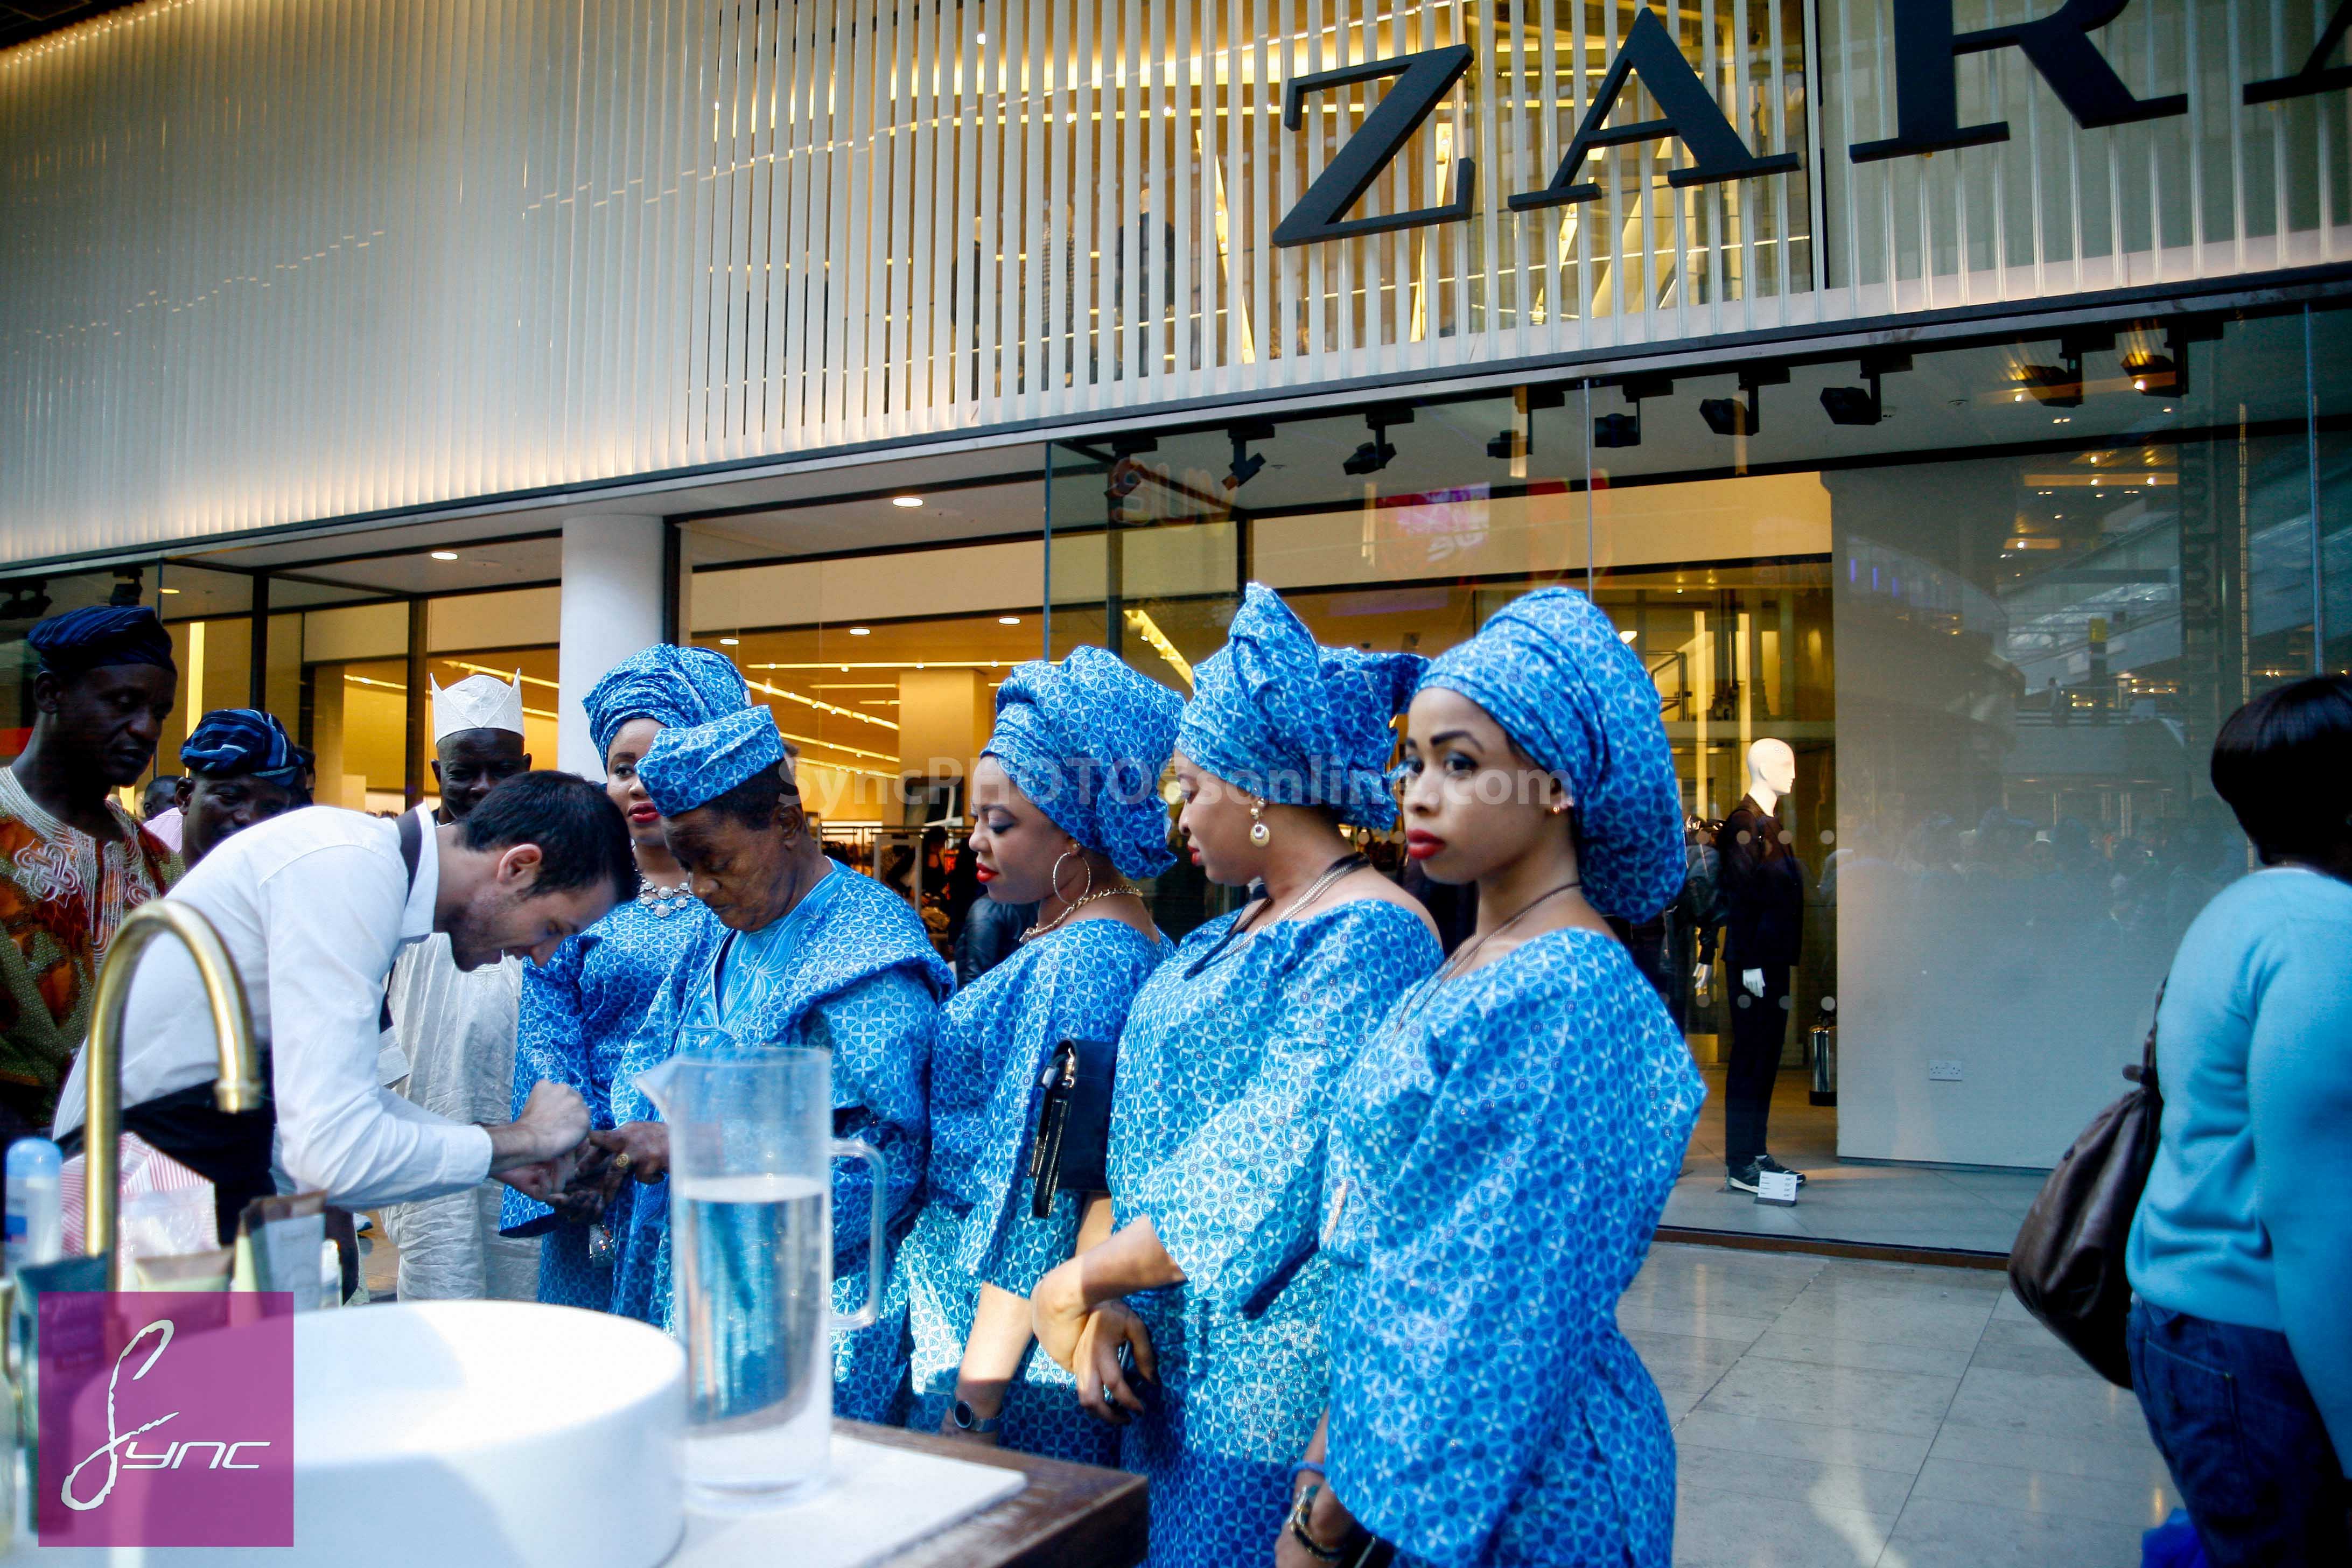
[983,647,1183,877]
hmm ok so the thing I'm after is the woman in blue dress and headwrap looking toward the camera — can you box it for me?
[1289,587,1705,1568]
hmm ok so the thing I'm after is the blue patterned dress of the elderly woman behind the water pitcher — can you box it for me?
[614,863,955,1422]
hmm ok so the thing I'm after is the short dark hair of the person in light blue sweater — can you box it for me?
[2213,675,2352,863]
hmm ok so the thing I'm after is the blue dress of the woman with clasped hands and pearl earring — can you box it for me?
[1110,898,1442,1568]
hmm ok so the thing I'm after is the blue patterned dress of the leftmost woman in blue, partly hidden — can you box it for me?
[499,898,717,1324]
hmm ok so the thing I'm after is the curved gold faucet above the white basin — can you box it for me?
[82,898,263,1291]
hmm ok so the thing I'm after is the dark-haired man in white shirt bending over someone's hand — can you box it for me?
[57,773,638,1239]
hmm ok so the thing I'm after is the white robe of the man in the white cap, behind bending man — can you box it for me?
[383,933,538,1303]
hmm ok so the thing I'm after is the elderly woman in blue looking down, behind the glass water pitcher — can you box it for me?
[612,708,955,1420]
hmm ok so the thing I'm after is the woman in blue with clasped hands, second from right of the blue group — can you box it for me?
[1030,583,1442,1568]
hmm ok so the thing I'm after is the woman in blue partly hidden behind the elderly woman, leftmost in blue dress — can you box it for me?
[499,642,748,1321]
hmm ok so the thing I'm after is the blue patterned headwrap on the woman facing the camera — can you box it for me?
[1420,587,1689,921]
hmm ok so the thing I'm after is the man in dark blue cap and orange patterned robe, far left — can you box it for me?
[0,604,179,1136]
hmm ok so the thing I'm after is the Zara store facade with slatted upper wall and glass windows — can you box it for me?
[0,0,2352,1251]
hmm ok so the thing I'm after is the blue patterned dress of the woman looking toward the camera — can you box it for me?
[1336,928,1705,1568]
